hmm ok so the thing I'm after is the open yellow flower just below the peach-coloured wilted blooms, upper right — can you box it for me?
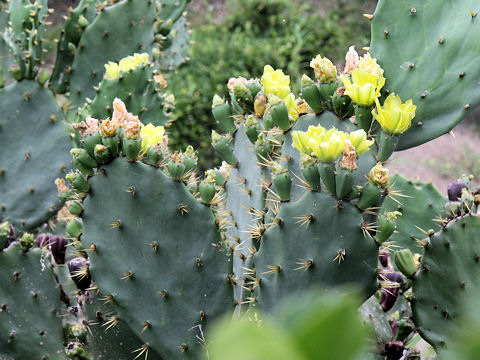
[340,68,385,108]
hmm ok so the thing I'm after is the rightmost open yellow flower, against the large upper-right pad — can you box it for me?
[372,93,417,134]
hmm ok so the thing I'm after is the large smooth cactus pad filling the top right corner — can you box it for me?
[370,0,480,150]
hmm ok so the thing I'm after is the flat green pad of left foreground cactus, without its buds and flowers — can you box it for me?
[80,158,234,359]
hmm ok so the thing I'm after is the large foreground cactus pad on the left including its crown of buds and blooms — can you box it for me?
[62,99,234,359]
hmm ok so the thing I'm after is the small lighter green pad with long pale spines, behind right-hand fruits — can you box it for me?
[379,175,447,254]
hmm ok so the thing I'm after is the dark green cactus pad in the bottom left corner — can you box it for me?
[0,243,66,359]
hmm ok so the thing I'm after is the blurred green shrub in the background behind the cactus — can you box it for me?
[169,0,369,168]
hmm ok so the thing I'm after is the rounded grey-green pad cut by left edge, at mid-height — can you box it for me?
[0,80,71,230]
